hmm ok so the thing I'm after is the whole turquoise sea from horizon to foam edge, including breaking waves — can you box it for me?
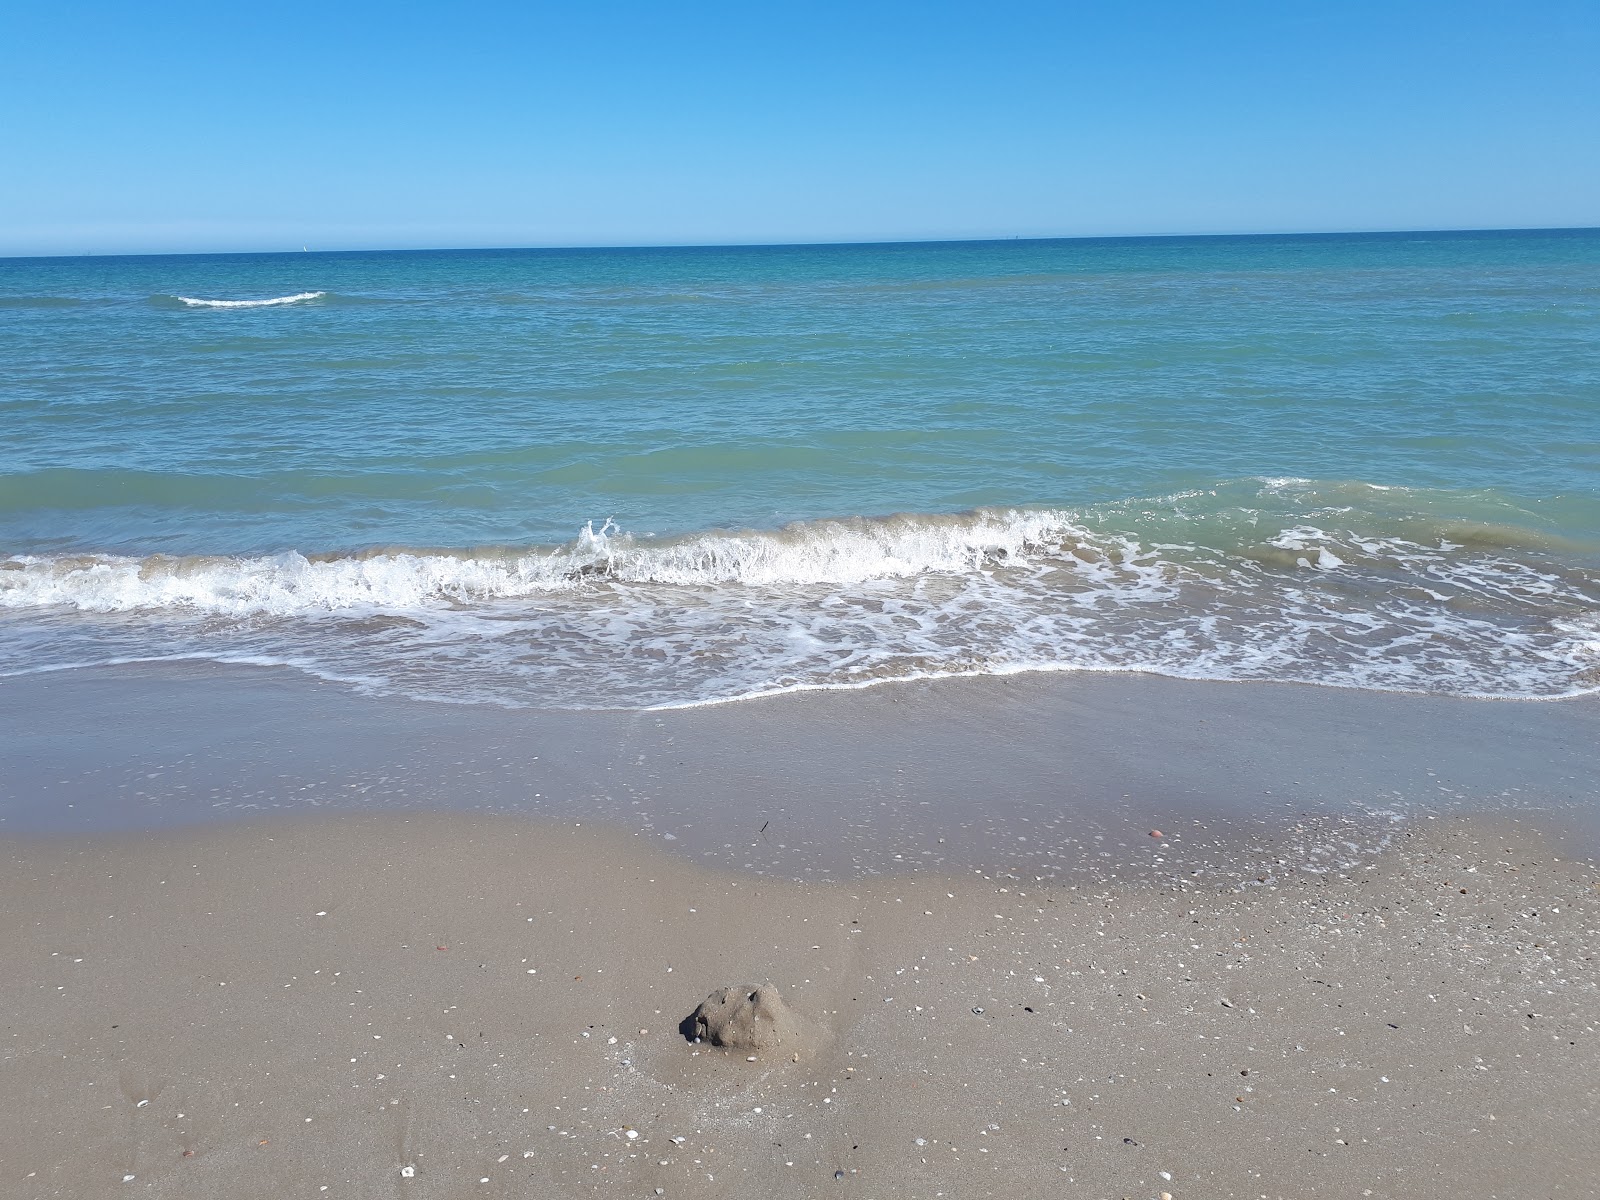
[0,230,1600,707]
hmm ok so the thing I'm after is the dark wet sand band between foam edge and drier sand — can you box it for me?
[0,662,1600,882]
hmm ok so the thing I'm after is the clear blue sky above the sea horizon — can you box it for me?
[0,0,1600,254]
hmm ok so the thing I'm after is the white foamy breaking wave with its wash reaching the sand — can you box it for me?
[0,504,1600,707]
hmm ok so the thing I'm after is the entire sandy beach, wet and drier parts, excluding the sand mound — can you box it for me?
[0,672,1600,1200]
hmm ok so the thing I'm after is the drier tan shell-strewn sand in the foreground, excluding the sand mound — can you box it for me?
[0,813,1600,1200]
